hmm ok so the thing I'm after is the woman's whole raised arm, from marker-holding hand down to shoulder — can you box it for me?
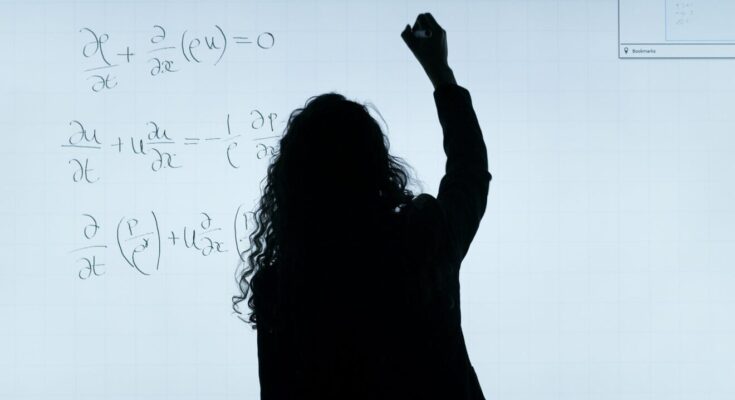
[401,13,492,267]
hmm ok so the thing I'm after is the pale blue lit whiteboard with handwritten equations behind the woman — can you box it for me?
[0,0,735,399]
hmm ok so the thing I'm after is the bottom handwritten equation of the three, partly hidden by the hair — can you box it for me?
[69,205,254,280]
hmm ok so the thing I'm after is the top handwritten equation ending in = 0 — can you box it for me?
[79,25,276,93]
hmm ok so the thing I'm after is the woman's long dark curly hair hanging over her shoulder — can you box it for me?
[232,92,422,329]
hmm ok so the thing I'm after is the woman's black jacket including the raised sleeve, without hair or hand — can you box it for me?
[257,84,492,400]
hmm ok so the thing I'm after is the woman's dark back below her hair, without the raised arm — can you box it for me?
[258,189,483,399]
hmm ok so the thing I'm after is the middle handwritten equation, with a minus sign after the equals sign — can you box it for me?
[61,109,285,184]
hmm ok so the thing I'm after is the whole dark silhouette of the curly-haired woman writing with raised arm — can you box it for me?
[233,13,491,400]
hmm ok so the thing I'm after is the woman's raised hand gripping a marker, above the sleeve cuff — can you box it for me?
[401,13,457,88]
